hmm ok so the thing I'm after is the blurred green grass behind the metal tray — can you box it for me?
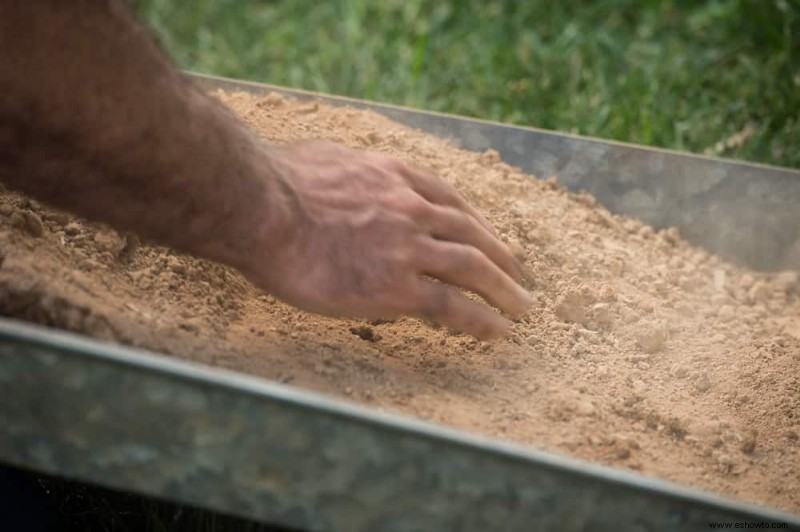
[129,0,800,167]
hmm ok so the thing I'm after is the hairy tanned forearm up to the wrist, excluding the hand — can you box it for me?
[0,0,283,267]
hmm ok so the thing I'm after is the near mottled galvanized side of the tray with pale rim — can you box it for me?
[0,319,800,531]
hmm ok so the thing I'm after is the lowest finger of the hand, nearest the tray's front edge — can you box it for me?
[417,279,511,340]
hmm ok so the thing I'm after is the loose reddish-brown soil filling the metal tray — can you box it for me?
[0,89,800,512]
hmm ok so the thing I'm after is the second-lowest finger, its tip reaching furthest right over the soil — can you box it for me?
[417,238,533,316]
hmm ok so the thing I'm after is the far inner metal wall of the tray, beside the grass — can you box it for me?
[192,74,800,270]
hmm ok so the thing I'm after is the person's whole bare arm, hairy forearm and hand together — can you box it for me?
[0,0,532,338]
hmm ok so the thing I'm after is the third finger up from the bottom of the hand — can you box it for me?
[423,205,523,283]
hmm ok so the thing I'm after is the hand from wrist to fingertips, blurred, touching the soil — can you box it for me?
[245,141,532,339]
